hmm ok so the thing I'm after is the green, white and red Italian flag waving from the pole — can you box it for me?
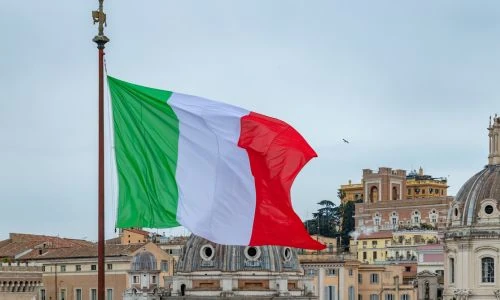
[108,76,324,249]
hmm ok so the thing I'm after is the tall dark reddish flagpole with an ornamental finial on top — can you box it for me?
[92,0,109,300]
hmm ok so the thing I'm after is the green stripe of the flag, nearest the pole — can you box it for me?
[108,76,183,228]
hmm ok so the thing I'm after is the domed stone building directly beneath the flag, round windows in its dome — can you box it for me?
[165,235,317,299]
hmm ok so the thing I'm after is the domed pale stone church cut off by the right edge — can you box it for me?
[444,115,500,300]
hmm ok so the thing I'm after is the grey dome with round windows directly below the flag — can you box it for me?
[177,235,301,273]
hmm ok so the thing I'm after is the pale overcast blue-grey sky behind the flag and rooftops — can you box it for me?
[0,0,500,240]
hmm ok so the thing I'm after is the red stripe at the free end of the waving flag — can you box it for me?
[238,112,325,250]
